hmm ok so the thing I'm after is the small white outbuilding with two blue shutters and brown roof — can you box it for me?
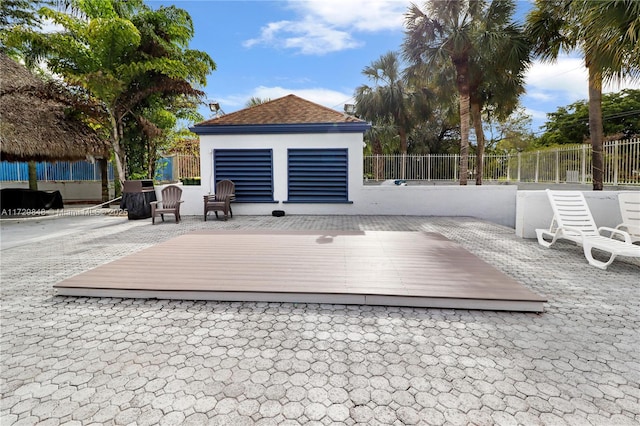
[191,95,370,214]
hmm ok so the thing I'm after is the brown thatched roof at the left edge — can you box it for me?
[0,54,110,161]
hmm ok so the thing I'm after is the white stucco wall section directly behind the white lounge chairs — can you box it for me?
[515,191,622,238]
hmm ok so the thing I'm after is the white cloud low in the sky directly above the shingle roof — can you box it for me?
[218,86,352,113]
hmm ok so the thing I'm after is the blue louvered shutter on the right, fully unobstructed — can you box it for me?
[288,149,349,203]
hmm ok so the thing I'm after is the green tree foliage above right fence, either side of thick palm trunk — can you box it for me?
[538,89,640,146]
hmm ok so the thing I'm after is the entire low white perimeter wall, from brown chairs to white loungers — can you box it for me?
[151,185,640,238]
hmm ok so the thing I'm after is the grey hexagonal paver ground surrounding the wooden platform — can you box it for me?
[0,216,640,426]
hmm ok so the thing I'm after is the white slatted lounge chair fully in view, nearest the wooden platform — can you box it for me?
[536,189,640,269]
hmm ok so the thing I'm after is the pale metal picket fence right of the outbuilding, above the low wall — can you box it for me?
[364,139,640,185]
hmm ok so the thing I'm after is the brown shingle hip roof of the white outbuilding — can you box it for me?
[196,95,364,127]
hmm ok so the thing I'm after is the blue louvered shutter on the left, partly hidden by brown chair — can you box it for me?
[213,149,273,203]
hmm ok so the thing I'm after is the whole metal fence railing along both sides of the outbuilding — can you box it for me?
[0,139,640,185]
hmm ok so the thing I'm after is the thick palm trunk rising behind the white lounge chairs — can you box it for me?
[587,60,604,191]
